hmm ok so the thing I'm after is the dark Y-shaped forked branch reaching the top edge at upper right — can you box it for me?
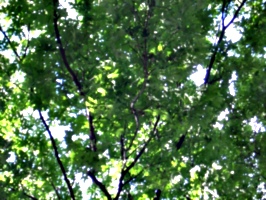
[204,0,247,85]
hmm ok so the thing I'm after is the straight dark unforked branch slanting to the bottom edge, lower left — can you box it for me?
[38,110,75,200]
